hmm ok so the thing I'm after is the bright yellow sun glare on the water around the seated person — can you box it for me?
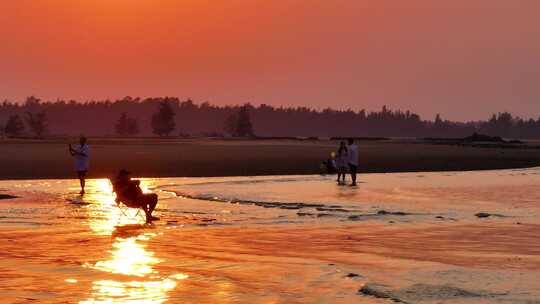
[79,179,188,304]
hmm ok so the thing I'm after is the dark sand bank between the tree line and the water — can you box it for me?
[0,139,540,179]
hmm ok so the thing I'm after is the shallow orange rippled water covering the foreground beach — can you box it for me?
[0,168,540,303]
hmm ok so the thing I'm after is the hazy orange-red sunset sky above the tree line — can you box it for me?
[0,0,540,120]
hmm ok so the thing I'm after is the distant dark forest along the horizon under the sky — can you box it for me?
[0,97,540,139]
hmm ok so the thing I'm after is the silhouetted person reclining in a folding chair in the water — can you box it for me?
[113,169,159,222]
